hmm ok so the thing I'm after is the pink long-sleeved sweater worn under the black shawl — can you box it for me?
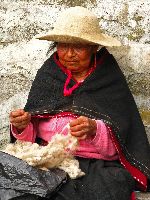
[11,116,118,160]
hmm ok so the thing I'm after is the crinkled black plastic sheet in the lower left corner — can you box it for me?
[0,152,67,200]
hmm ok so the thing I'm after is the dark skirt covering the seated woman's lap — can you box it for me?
[50,158,134,200]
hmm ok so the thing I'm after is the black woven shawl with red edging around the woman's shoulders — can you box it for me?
[25,48,150,190]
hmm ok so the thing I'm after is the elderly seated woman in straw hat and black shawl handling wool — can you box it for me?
[10,7,150,200]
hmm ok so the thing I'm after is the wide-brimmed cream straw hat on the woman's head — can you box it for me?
[36,6,121,46]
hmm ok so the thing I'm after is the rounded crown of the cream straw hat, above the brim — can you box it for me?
[54,6,100,35]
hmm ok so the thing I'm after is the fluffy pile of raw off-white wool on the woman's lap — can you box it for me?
[4,130,85,179]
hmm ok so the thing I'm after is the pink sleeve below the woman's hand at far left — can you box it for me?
[11,122,36,142]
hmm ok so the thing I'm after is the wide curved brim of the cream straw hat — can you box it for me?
[35,31,121,47]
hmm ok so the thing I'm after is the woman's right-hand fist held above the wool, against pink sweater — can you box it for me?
[70,116,97,140]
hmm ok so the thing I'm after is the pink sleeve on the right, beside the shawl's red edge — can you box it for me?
[90,120,117,157]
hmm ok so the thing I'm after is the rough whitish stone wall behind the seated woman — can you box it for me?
[0,0,150,199]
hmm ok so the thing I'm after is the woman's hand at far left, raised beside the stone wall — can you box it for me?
[9,109,31,131]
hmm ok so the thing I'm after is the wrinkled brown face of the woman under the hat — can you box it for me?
[57,43,98,73]
